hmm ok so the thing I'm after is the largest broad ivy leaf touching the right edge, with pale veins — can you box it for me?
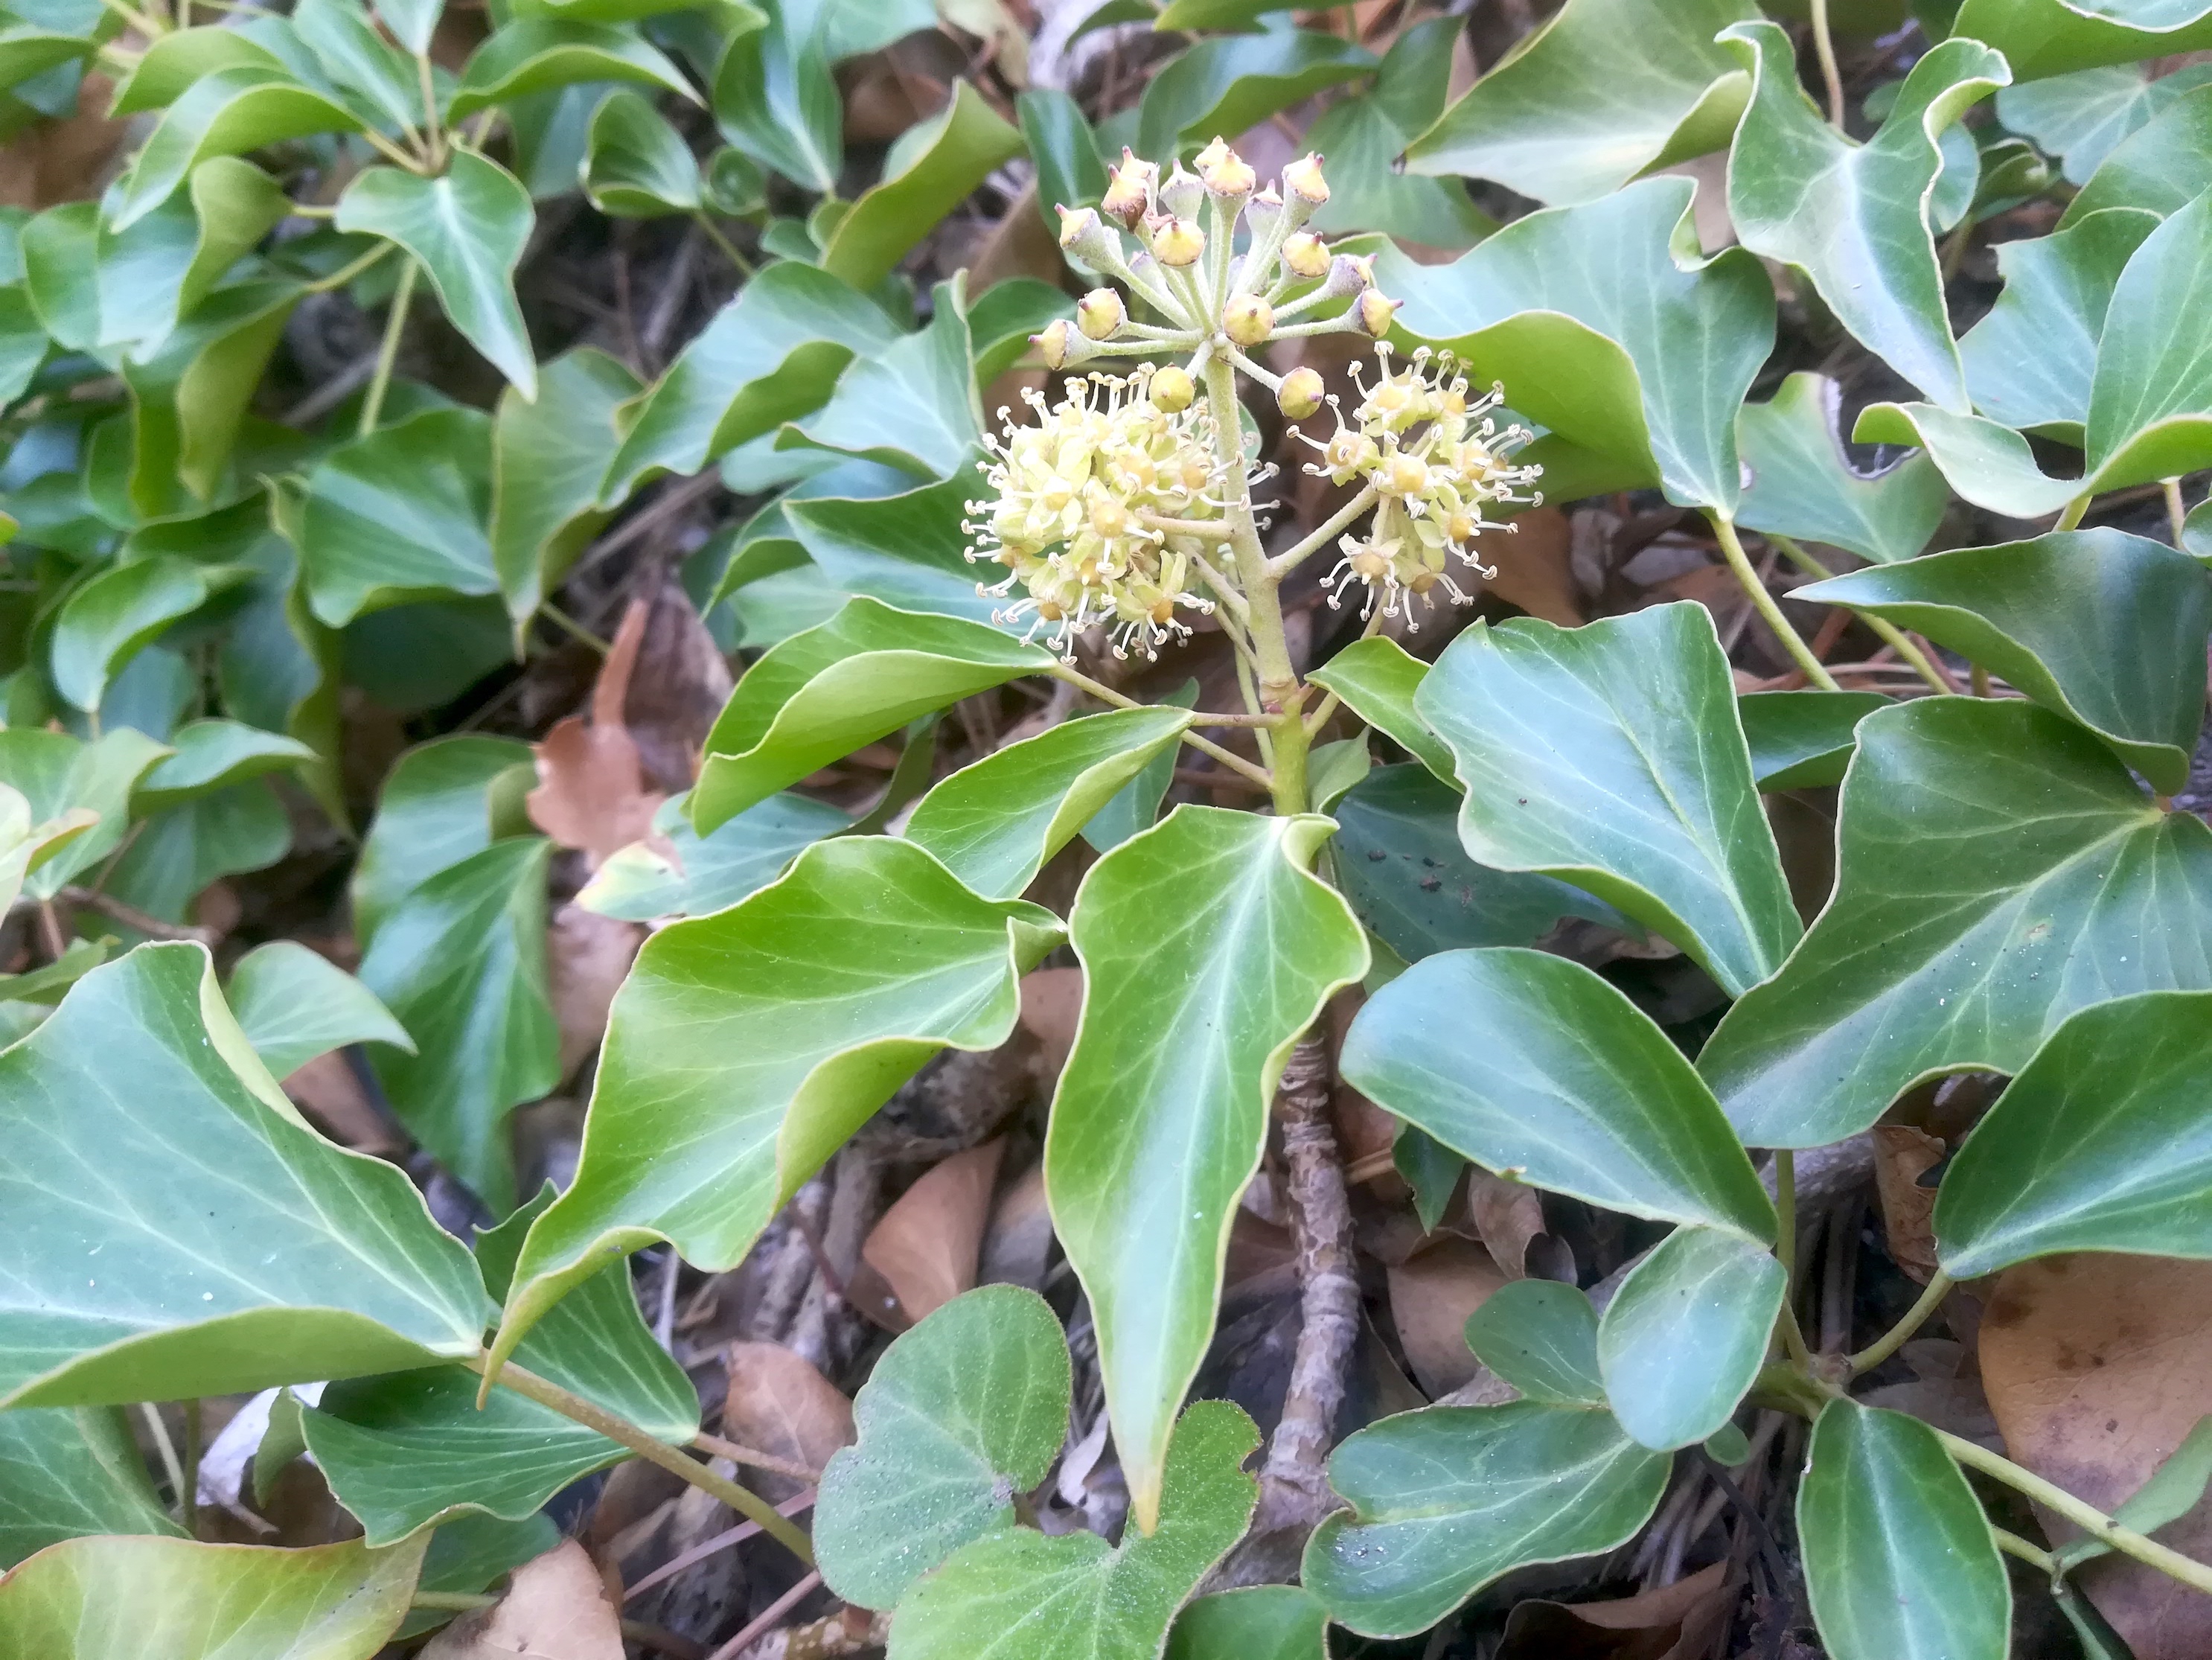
[1698,697,2212,1146]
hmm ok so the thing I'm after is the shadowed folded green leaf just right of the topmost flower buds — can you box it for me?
[1305,18,1497,248]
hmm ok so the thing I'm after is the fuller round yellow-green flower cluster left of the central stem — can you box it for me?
[962,370,1224,662]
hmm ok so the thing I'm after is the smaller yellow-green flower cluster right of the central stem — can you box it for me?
[1305,345,1544,631]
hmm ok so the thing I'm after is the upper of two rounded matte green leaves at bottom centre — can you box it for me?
[814,1286,1075,1609]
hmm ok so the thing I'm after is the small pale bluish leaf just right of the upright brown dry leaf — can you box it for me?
[575,790,851,923]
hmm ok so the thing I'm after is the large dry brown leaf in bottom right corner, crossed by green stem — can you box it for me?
[1982,1253,2212,1660]
